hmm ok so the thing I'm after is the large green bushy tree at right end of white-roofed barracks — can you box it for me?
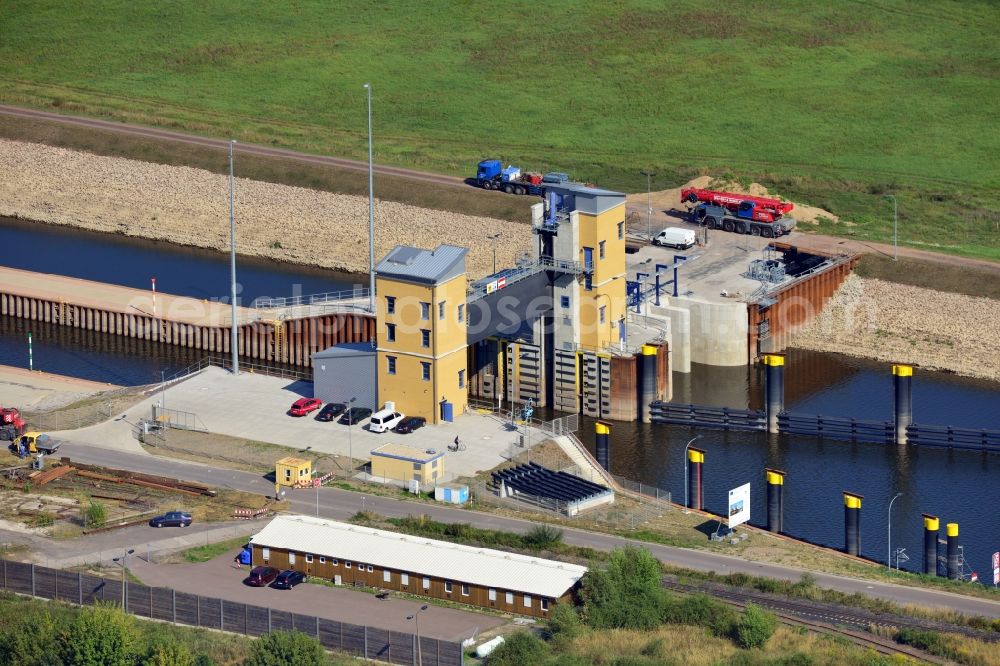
[581,546,667,630]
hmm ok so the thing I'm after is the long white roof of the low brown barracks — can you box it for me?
[251,515,587,598]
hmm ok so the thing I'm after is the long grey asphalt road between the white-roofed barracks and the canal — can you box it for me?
[61,443,1000,618]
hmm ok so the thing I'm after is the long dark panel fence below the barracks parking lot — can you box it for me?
[0,560,464,666]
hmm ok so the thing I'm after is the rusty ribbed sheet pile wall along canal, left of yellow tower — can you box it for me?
[0,292,375,367]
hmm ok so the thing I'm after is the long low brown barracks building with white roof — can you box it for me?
[250,515,587,617]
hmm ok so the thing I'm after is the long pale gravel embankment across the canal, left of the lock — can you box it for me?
[0,140,531,278]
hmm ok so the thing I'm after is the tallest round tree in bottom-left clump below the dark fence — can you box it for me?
[64,603,137,666]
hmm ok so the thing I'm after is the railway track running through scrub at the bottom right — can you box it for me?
[663,576,1000,664]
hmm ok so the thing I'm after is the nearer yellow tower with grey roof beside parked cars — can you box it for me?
[375,245,468,423]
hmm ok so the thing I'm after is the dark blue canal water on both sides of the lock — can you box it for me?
[0,218,1000,582]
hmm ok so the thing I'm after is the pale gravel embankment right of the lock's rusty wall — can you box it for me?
[793,275,1000,381]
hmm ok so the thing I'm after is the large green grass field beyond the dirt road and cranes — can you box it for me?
[0,0,1000,259]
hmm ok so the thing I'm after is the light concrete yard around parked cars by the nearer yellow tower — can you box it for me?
[53,367,544,480]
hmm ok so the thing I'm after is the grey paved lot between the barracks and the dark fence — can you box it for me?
[129,553,507,641]
